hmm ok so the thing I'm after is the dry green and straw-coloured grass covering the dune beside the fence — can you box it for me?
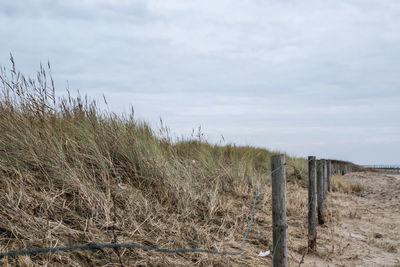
[0,59,307,266]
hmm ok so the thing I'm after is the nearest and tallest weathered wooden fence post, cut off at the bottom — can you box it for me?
[271,154,287,267]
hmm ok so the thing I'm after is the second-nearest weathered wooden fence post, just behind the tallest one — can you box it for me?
[308,156,317,251]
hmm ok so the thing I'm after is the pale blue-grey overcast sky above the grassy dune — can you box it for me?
[0,0,400,164]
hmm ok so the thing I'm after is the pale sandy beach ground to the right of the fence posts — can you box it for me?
[301,173,400,266]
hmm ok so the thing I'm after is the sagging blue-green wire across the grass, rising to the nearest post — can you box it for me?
[0,164,286,259]
